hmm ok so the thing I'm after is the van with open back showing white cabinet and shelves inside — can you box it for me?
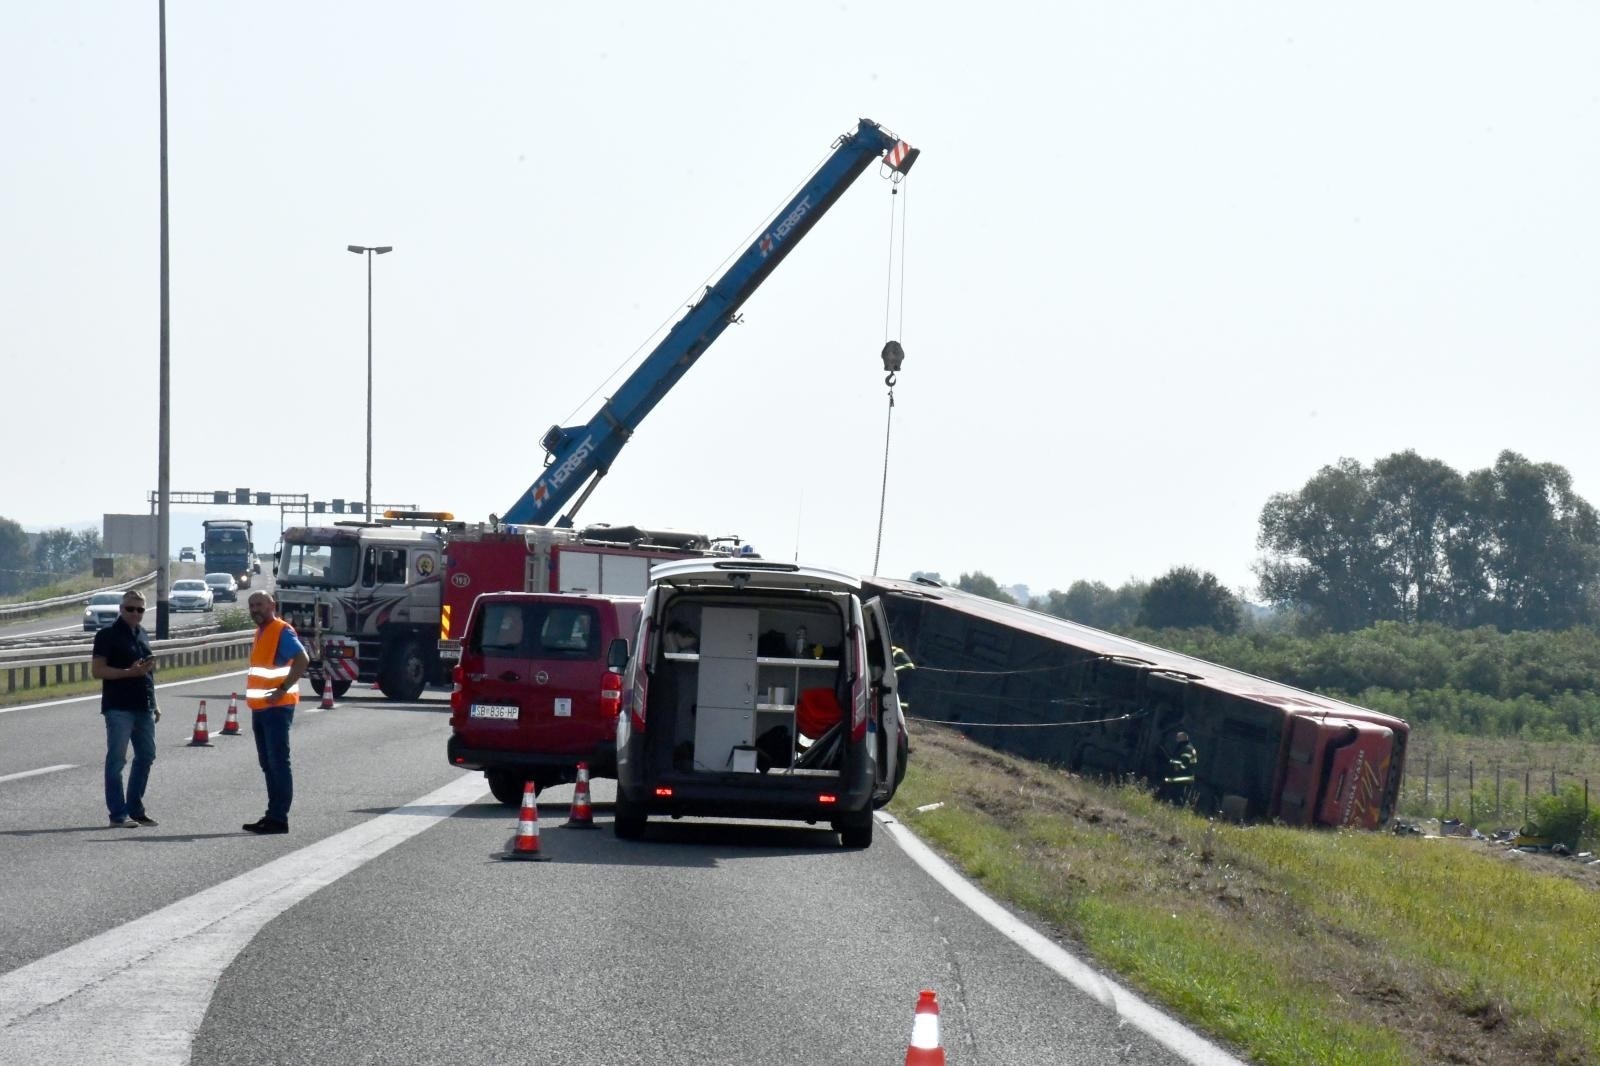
[614,559,907,847]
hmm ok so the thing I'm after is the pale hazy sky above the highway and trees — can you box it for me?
[0,0,1600,594]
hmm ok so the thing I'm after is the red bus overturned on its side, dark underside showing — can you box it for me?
[864,578,1410,828]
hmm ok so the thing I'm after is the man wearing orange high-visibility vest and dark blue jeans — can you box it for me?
[245,591,310,832]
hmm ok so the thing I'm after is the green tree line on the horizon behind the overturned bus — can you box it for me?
[958,451,1600,632]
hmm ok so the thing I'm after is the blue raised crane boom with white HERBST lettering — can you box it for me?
[502,118,920,527]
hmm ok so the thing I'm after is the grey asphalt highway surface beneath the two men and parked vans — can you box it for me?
[0,675,1230,1066]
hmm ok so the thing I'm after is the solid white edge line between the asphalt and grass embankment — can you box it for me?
[877,812,1245,1066]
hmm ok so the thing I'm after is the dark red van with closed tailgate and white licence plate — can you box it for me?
[445,592,642,807]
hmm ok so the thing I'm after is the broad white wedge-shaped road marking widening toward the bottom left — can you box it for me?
[0,775,485,1066]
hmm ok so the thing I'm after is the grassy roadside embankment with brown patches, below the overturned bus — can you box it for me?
[891,727,1600,1066]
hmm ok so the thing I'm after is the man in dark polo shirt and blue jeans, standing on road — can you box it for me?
[90,589,162,829]
